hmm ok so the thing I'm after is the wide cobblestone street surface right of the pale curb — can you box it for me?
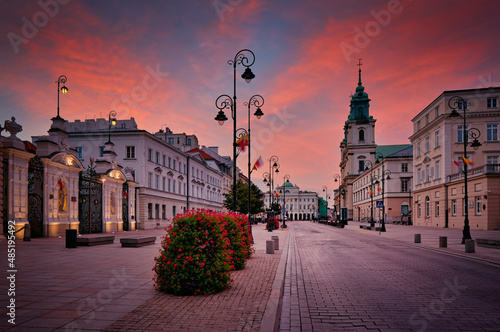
[280,222,500,331]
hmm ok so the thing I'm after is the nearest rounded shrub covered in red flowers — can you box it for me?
[154,210,232,295]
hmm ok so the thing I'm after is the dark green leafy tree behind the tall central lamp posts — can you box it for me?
[224,180,264,214]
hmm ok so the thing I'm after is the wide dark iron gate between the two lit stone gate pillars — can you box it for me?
[78,171,102,234]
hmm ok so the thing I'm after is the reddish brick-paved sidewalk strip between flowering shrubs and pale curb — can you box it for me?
[105,224,288,332]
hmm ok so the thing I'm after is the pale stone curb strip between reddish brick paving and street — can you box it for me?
[259,227,291,332]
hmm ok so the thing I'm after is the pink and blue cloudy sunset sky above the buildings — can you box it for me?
[0,0,500,194]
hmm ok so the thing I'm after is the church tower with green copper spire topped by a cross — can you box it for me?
[340,59,377,220]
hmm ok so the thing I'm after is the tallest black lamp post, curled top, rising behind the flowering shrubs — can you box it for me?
[215,49,255,211]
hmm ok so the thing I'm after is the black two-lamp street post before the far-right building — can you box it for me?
[448,96,481,244]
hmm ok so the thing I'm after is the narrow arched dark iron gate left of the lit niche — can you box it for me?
[28,156,43,237]
